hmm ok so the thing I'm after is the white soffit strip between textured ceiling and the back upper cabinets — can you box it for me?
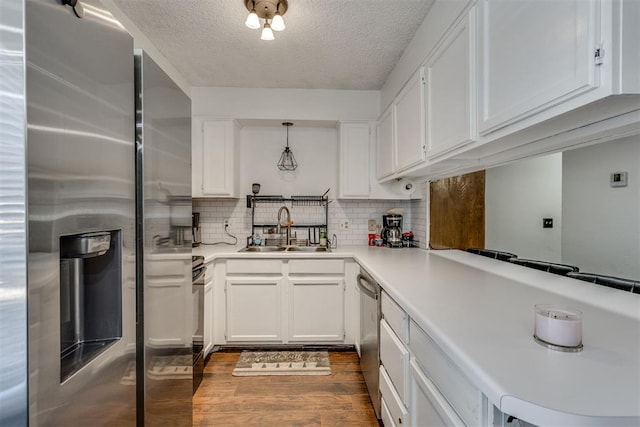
[191,87,380,122]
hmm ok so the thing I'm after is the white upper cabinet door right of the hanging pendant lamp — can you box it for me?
[339,122,371,198]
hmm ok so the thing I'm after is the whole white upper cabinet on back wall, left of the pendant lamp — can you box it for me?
[191,120,238,197]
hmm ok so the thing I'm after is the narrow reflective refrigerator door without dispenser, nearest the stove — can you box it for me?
[135,49,193,426]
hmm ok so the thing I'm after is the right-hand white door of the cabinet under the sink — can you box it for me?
[289,277,345,342]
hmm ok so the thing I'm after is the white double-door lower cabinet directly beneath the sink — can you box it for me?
[220,259,355,344]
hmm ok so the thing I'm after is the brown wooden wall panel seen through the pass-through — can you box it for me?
[429,171,485,250]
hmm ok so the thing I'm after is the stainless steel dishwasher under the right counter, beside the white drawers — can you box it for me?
[358,269,381,419]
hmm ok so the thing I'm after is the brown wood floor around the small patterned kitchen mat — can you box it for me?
[193,352,378,427]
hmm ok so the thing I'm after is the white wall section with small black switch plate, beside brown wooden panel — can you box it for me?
[485,153,564,262]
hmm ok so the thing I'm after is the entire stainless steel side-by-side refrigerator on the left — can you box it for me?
[0,0,193,426]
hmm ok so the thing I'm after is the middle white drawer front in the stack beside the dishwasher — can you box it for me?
[380,320,409,403]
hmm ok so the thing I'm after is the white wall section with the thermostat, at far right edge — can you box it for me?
[562,136,640,279]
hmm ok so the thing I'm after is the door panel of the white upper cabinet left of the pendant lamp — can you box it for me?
[199,120,237,197]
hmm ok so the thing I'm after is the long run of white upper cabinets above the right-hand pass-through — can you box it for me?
[377,0,640,180]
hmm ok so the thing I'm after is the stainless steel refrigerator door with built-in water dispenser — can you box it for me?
[23,0,137,426]
